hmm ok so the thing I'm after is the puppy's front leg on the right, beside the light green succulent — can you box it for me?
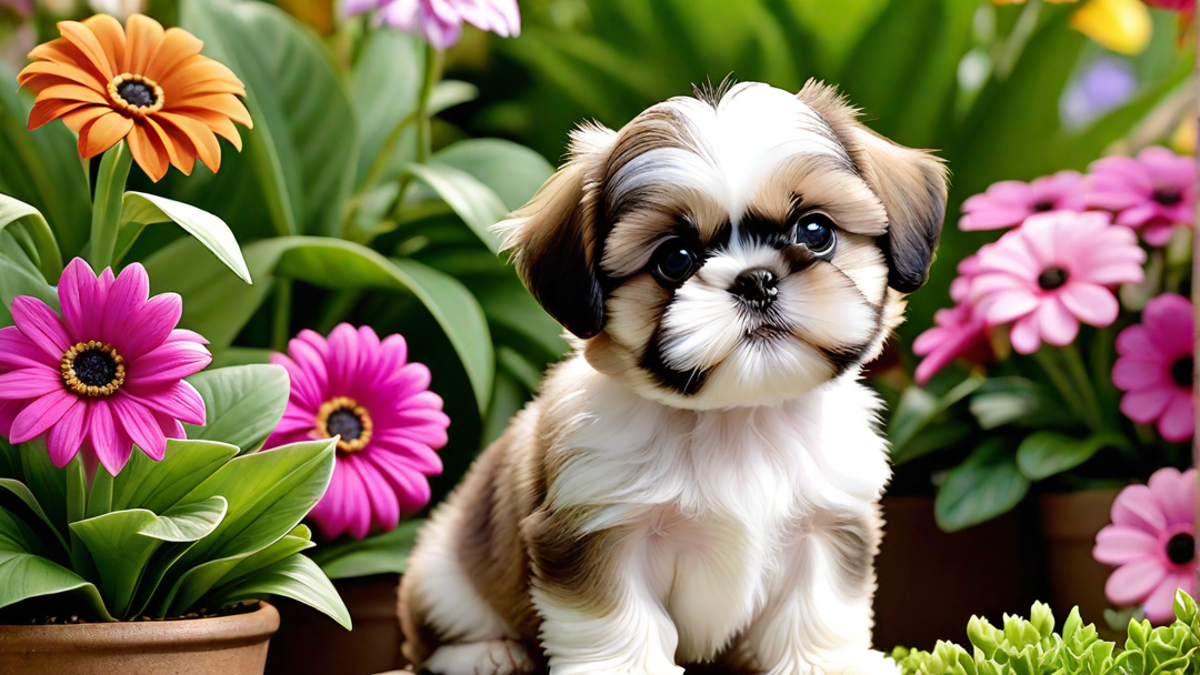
[738,509,900,675]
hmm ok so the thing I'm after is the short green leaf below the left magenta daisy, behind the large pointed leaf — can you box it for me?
[112,438,239,513]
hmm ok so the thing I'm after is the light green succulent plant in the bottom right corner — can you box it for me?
[892,590,1200,675]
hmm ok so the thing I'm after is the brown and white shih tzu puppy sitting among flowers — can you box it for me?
[401,82,947,675]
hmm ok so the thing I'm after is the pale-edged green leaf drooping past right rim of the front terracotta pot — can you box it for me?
[201,554,352,631]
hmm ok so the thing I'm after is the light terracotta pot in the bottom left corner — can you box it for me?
[0,603,280,675]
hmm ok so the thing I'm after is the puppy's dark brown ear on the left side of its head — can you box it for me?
[493,126,616,339]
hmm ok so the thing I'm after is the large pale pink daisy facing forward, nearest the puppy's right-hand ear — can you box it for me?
[970,211,1146,354]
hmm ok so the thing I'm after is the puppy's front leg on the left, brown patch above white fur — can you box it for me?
[524,510,683,675]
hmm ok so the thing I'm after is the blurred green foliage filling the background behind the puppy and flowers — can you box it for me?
[0,0,1196,509]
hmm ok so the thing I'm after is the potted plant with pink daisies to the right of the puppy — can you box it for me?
[890,147,1196,616]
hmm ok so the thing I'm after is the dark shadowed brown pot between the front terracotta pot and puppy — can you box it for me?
[267,574,408,675]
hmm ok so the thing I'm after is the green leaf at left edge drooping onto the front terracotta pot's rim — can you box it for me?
[0,509,113,621]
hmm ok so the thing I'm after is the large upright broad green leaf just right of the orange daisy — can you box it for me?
[180,0,359,234]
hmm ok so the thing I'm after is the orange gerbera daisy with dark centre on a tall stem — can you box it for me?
[17,14,253,181]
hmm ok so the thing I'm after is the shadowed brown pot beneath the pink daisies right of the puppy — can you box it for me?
[1038,489,1120,632]
